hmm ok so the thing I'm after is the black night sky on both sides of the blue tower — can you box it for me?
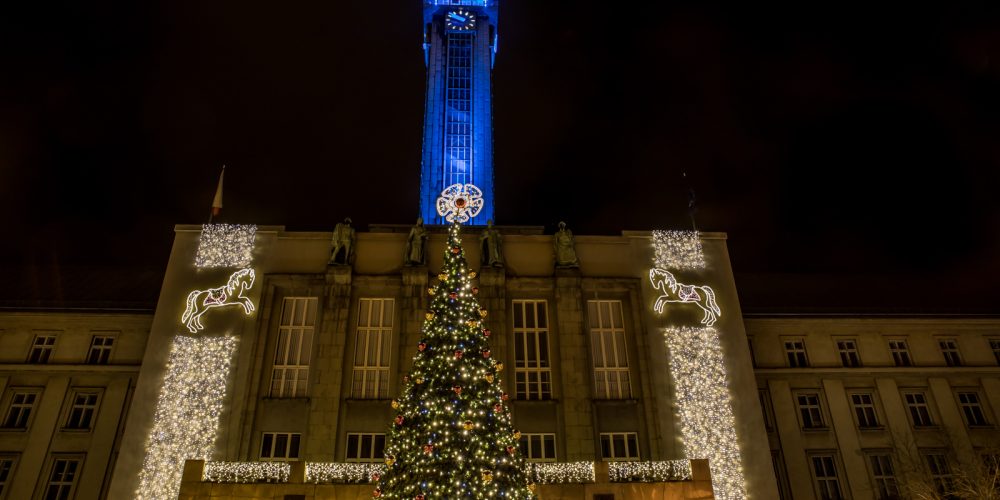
[0,0,1000,313]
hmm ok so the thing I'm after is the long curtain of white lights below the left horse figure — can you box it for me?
[135,336,239,500]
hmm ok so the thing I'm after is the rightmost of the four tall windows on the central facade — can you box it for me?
[588,300,632,399]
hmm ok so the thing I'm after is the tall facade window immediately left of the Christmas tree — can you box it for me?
[351,299,395,399]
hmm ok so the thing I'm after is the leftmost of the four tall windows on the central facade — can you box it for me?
[271,297,317,398]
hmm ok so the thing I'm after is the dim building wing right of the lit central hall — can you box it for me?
[745,315,1000,500]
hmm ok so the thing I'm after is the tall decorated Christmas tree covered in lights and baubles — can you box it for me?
[373,222,534,500]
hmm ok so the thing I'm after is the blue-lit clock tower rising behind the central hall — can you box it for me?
[420,0,499,224]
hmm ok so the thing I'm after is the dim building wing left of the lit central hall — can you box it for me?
[0,311,152,500]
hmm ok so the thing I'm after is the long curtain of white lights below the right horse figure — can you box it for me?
[663,327,747,500]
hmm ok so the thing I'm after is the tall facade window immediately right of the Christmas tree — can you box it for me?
[513,300,552,399]
